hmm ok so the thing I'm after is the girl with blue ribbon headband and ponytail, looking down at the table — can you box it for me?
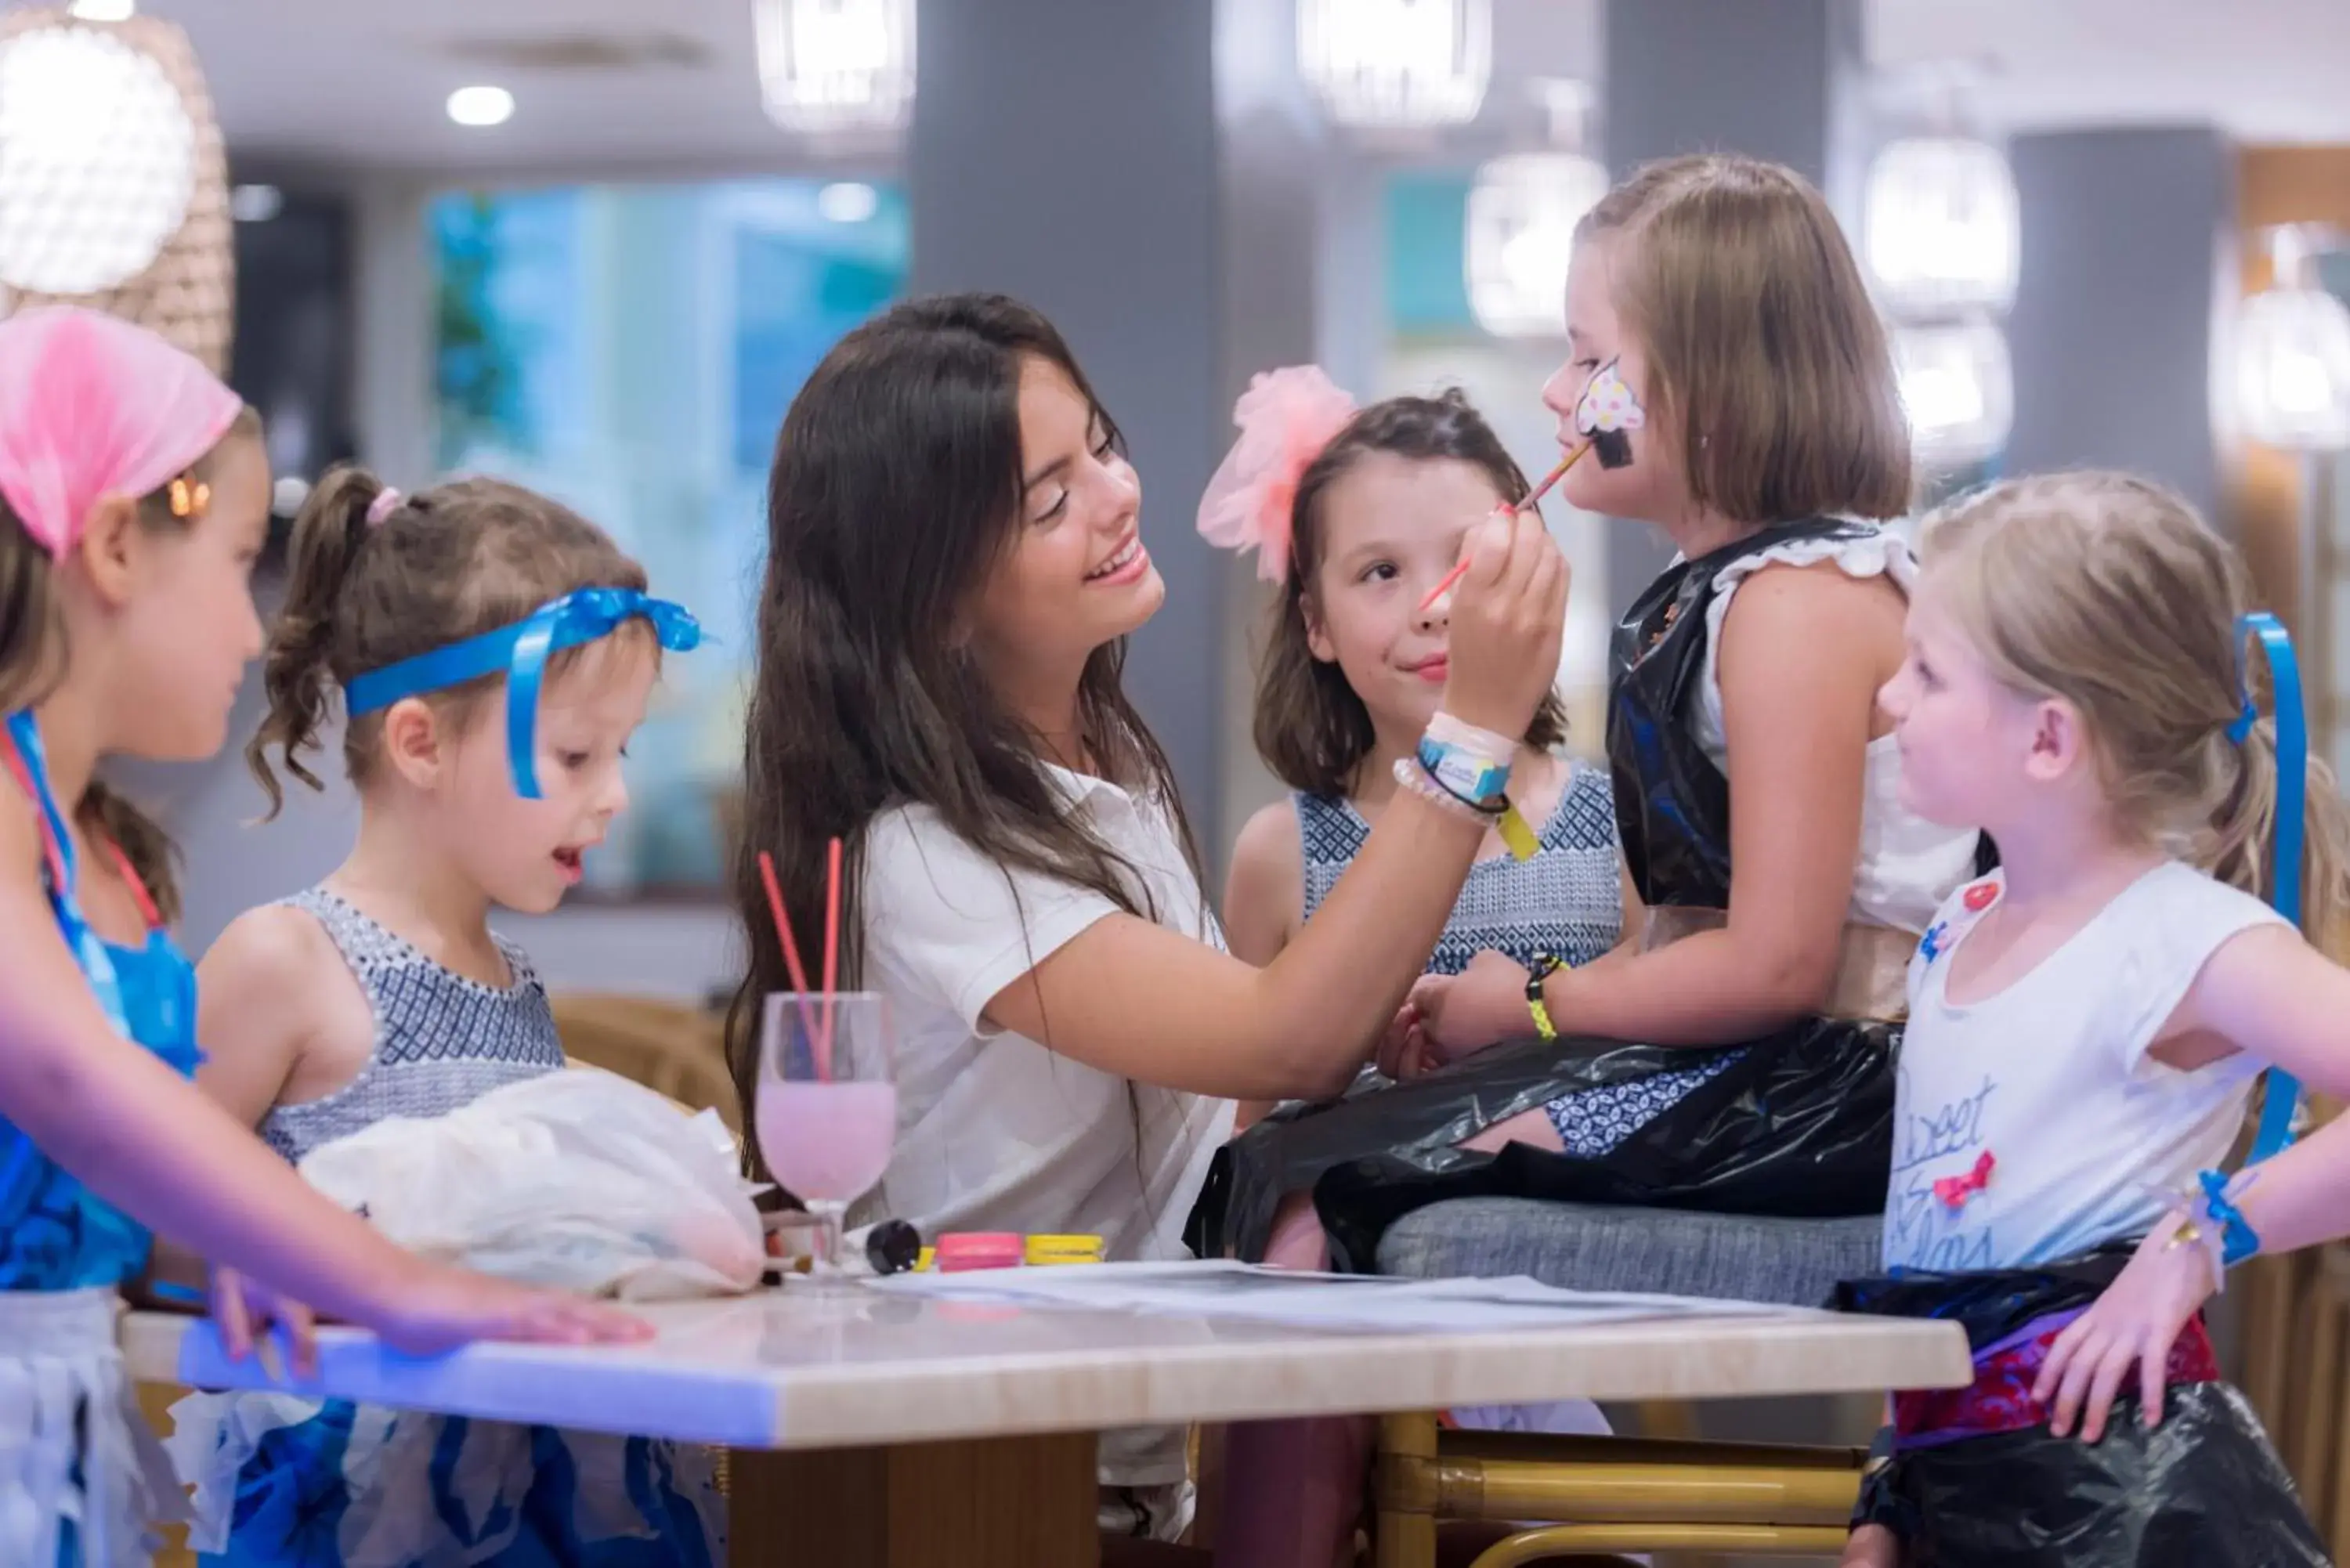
[172,470,724,1568]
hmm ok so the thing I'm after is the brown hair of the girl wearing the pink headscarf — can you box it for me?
[0,409,261,924]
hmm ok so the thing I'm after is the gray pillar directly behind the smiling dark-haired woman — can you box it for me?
[907,0,1229,835]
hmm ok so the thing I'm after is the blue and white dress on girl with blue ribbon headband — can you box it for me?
[169,889,726,1568]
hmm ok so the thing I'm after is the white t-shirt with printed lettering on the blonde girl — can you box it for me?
[1885,861,2282,1272]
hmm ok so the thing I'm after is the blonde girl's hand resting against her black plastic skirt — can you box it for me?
[2033,1216,2218,1443]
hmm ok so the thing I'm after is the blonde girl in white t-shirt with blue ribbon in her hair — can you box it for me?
[1845,472,2350,1568]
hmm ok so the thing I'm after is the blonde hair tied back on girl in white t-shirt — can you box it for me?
[1925,472,2350,950]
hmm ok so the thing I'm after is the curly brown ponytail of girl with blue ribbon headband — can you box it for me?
[244,463,385,821]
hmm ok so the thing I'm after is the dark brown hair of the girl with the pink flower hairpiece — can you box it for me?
[1255,388,1567,795]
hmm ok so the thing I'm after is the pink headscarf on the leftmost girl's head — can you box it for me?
[0,305,244,557]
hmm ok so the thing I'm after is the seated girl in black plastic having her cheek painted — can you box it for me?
[1208,157,1976,1300]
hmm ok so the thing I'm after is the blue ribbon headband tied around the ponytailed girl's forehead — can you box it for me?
[343,587,703,800]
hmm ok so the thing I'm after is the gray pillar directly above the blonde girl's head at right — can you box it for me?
[2005,125,2235,519]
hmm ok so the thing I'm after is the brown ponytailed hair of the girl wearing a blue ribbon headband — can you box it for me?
[244,465,644,816]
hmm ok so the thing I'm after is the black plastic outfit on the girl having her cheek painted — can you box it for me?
[1189,522,1901,1270]
